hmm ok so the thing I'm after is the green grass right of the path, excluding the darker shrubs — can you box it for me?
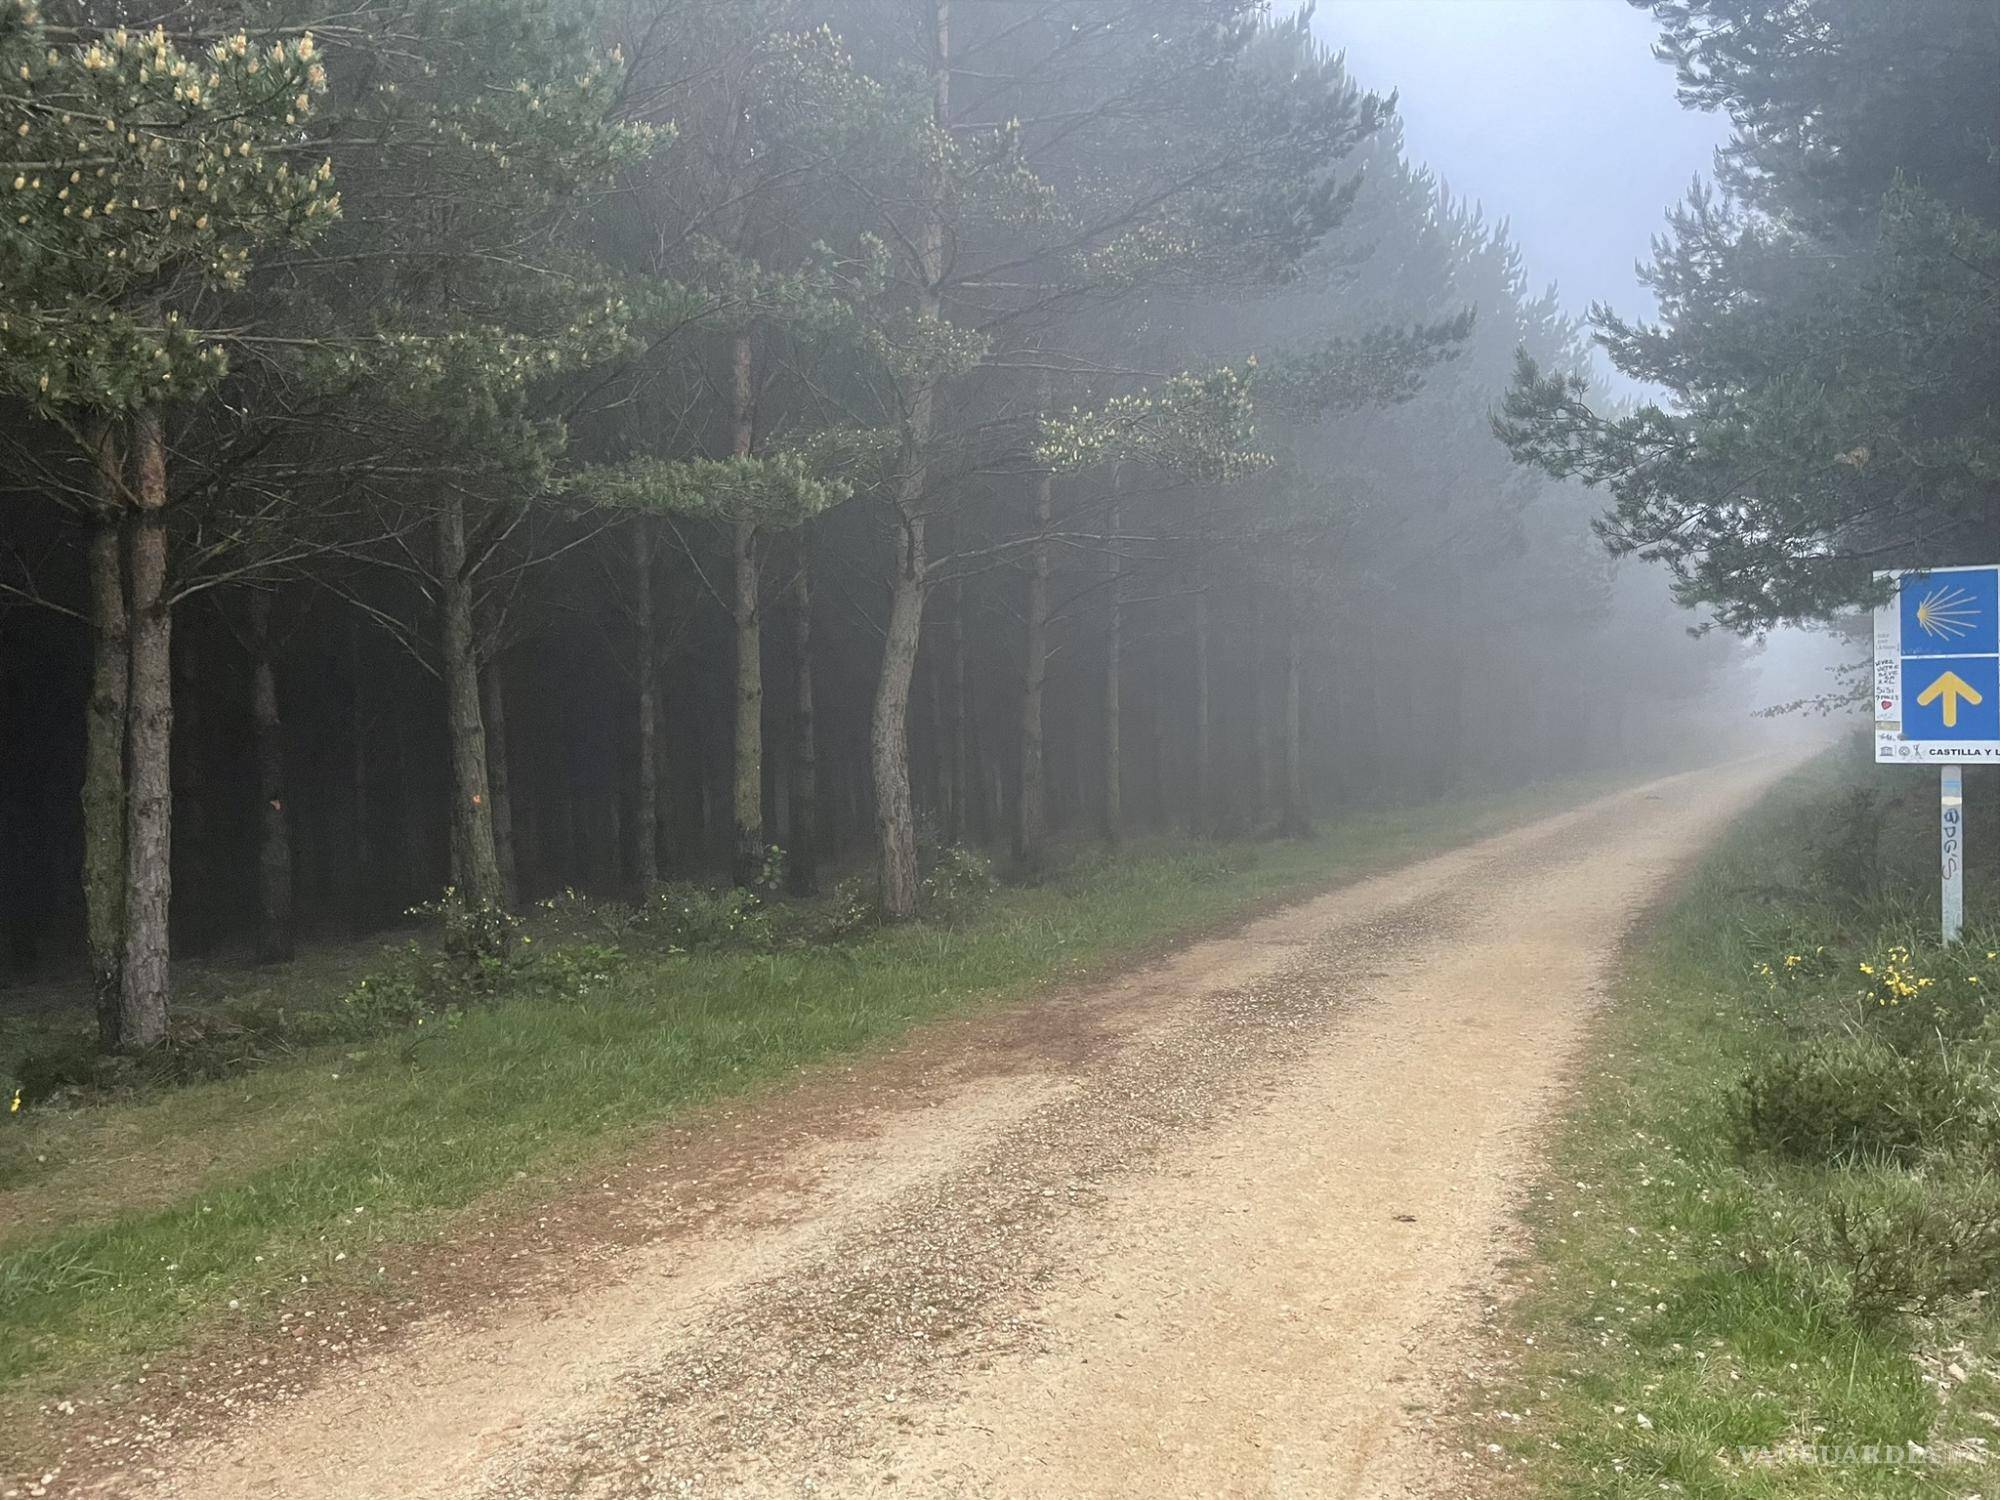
[1480,748,2000,1500]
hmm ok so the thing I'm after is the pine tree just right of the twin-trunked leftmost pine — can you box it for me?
[300,0,658,906]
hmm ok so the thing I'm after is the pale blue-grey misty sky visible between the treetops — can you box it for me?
[1316,0,1728,354]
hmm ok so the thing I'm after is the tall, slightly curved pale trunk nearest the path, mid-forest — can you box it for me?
[868,0,952,922]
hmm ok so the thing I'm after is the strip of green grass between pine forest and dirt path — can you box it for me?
[0,784,1616,1428]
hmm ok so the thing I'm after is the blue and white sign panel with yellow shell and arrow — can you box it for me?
[1874,568,2000,764]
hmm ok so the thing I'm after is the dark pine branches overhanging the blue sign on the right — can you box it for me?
[1498,0,2000,634]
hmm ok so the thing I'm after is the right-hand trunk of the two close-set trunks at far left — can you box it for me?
[118,408,174,1052]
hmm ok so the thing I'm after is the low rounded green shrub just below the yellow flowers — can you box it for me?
[1734,1036,1996,1162]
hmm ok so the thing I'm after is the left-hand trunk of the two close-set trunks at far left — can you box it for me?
[82,424,132,1052]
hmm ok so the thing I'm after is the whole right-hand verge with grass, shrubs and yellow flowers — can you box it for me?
[1476,748,2000,1500]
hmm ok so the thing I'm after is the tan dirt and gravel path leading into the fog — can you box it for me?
[92,762,1780,1500]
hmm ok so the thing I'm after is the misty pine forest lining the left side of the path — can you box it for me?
[0,0,1736,1048]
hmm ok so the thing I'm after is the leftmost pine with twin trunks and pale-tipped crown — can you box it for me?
[0,0,340,1050]
